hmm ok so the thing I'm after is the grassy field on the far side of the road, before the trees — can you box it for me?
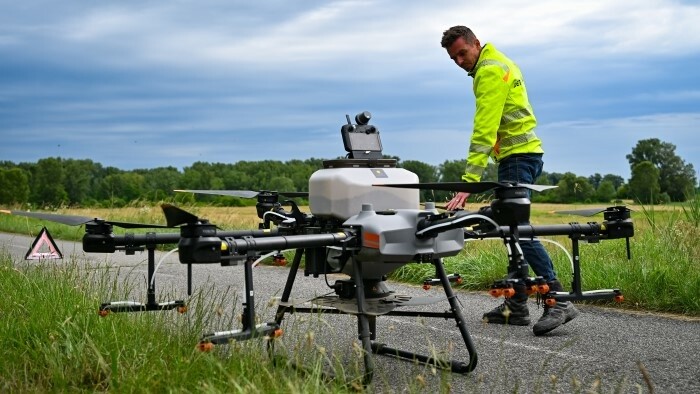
[0,200,700,316]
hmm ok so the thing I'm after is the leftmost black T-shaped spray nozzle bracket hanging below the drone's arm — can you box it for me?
[98,243,187,317]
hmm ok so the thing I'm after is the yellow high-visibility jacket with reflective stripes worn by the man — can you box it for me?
[462,43,544,182]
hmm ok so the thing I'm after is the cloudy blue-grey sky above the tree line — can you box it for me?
[0,0,700,180]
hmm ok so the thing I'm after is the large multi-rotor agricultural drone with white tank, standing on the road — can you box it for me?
[1,112,634,384]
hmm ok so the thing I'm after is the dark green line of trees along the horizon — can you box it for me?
[0,139,697,208]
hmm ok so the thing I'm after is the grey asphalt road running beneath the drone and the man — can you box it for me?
[0,233,700,393]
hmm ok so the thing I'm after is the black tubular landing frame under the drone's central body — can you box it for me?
[276,249,477,385]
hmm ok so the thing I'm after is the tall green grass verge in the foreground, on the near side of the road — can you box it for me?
[0,250,653,393]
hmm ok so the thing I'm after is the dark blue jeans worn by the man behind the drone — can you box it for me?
[498,153,557,282]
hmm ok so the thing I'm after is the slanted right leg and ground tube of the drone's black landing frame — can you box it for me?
[372,259,478,373]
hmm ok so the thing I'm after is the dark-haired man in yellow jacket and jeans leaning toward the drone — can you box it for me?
[441,26,579,335]
